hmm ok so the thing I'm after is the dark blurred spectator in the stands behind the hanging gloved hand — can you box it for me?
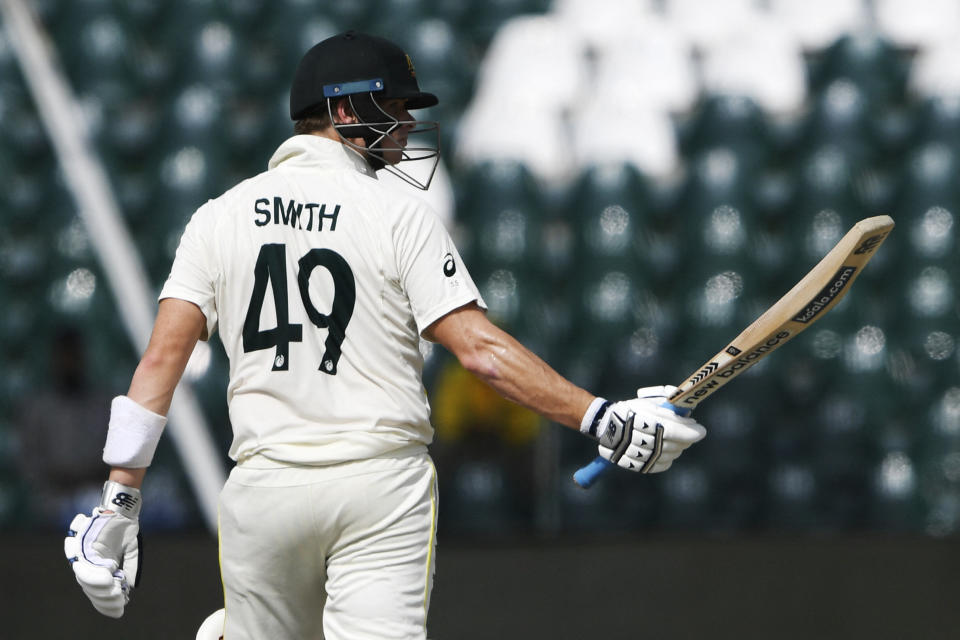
[14,327,110,529]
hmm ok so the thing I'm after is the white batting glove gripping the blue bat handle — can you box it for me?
[580,386,707,473]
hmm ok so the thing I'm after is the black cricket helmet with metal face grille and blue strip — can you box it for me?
[290,31,440,189]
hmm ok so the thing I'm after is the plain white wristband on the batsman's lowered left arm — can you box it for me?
[103,396,167,469]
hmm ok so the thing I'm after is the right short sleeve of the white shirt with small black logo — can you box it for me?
[394,205,487,335]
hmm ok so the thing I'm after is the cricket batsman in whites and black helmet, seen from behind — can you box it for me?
[65,32,706,640]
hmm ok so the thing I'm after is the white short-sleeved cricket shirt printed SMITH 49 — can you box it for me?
[160,135,486,465]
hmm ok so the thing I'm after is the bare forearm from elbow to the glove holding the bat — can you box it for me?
[460,325,594,429]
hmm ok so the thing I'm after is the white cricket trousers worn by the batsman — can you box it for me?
[220,453,437,640]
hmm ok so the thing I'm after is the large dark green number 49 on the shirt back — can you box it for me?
[243,244,357,375]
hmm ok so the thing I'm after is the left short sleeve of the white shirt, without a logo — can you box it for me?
[158,202,217,339]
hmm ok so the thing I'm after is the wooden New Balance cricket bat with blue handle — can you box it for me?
[573,216,894,489]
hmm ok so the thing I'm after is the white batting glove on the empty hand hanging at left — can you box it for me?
[63,481,140,618]
